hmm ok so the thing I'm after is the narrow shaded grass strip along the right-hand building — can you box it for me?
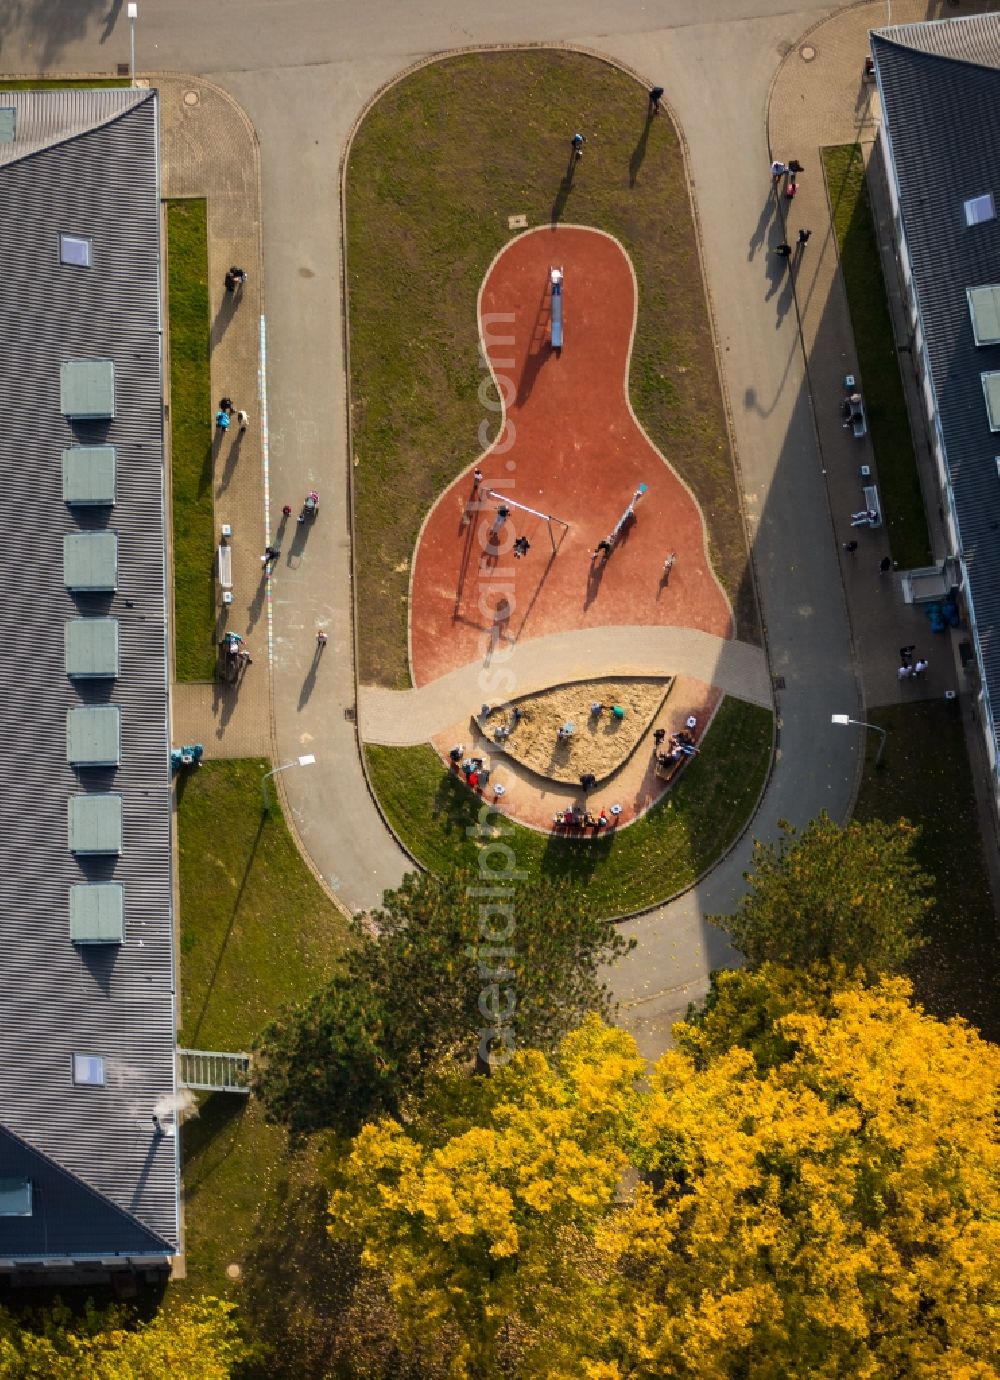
[823,144,931,570]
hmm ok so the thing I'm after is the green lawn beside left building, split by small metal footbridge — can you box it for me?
[172,760,346,1297]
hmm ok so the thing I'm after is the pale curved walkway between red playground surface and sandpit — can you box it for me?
[357,627,771,747]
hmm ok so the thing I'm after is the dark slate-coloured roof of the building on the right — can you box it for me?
[872,15,1000,739]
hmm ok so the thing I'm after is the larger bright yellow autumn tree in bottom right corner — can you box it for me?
[595,973,1000,1380]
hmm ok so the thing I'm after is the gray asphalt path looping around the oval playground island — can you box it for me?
[0,0,859,1053]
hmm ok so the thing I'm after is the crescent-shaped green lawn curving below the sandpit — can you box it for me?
[364,698,771,916]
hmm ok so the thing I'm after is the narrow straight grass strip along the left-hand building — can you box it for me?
[167,197,215,680]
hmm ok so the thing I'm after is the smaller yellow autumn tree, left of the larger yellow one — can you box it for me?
[330,1017,644,1376]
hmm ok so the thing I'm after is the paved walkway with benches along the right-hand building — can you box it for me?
[753,0,959,709]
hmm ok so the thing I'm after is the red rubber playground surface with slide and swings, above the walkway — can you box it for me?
[410,226,732,686]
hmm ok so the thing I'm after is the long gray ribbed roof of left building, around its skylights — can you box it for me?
[0,83,178,1260]
